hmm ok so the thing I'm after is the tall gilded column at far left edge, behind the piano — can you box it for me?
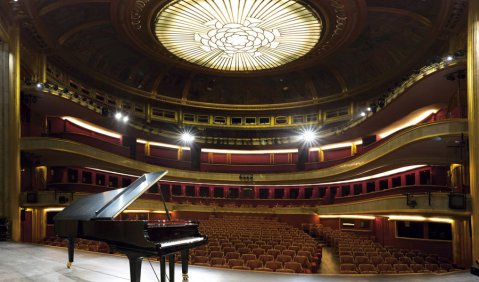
[0,23,21,241]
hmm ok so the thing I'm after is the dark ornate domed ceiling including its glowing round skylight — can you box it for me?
[15,0,465,111]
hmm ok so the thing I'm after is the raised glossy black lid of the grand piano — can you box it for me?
[54,171,168,220]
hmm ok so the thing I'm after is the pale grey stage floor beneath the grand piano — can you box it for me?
[0,242,478,282]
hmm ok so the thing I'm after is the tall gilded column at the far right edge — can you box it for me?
[467,1,479,261]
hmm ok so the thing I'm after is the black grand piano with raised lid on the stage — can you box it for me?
[54,171,208,282]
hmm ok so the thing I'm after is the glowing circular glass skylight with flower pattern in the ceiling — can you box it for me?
[154,0,322,72]
